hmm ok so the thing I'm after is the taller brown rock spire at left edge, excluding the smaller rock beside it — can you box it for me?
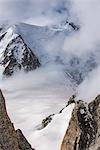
[0,90,19,150]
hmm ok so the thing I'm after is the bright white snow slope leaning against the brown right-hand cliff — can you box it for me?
[30,104,75,150]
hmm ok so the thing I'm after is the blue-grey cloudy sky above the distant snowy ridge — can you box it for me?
[0,0,71,25]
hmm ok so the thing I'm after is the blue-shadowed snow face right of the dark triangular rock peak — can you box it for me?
[16,23,72,64]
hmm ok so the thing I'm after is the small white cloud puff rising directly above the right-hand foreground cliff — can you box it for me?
[78,66,100,102]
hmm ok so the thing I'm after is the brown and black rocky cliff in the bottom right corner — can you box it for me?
[61,95,100,150]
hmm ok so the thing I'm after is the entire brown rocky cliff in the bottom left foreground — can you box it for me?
[0,91,34,150]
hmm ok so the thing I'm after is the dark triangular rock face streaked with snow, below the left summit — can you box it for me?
[0,33,40,76]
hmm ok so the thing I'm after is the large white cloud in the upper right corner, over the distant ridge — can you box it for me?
[64,0,100,53]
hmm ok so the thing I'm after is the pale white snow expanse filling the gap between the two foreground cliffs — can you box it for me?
[0,74,74,150]
